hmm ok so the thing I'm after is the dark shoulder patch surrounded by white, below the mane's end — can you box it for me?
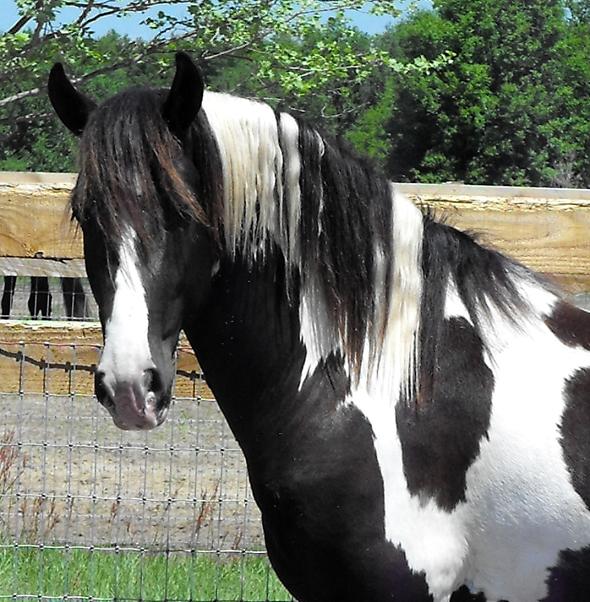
[396,318,494,511]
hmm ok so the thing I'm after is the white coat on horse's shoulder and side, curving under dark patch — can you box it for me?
[347,280,590,602]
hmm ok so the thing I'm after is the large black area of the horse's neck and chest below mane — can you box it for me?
[191,252,432,602]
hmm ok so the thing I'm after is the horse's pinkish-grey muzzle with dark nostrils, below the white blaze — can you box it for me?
[94,369,170,431]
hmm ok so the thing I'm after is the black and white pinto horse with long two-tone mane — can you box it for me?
[49,53,590,602]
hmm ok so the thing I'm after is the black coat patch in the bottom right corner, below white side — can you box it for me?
[541,546,590,602]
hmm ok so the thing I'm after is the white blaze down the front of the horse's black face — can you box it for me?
[98,229,154,386]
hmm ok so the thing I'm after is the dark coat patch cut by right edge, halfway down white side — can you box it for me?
[561,368,590,506]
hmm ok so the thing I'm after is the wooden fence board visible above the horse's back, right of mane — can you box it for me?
[398,184,590,292]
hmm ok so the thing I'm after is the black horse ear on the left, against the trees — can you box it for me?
[47,63,96,136]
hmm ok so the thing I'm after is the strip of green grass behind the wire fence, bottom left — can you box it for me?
[0,546,291,602]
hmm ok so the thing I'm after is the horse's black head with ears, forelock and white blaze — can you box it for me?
[48,53,215,429]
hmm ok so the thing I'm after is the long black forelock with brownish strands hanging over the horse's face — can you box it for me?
[71,88,206,245]
